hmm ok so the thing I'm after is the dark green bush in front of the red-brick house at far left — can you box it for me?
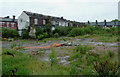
[2,28,19,38]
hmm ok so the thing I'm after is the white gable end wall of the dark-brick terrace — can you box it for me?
[18,12,30,30]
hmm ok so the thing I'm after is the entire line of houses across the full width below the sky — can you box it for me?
[0,11,120,35]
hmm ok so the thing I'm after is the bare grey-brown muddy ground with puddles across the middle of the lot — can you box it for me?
[2,37,118,64]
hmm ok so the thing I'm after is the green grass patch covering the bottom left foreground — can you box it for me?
[2,49,79,75]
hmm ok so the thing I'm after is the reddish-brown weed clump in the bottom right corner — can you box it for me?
[94,60,118,76]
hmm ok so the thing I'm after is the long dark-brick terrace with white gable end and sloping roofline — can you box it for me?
[18,11,72,34]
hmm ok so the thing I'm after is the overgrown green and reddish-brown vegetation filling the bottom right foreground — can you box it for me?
[69,46,119,76]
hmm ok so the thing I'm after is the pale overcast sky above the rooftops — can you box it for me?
[0,0,119,22]
